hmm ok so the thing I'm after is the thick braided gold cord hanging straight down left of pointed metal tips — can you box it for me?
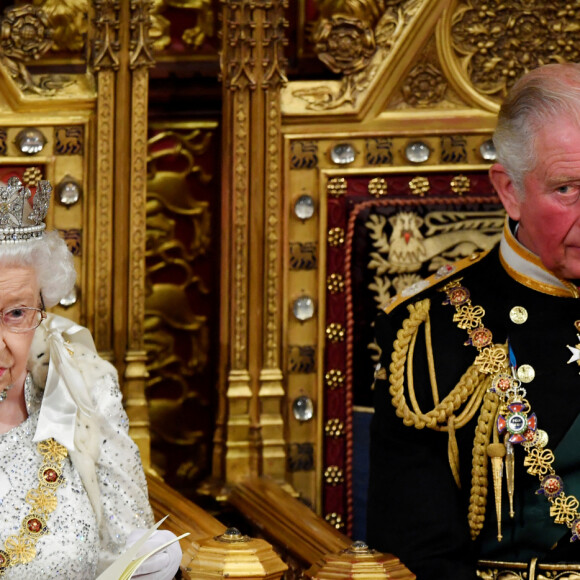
[467,386,499,540]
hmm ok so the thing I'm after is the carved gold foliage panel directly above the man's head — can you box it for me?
[452,0,580,99]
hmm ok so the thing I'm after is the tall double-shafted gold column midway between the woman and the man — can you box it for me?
[214,0,287,482]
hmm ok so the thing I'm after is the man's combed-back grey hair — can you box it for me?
[493,62,580,196]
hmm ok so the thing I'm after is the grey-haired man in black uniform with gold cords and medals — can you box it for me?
[367,63,580,580]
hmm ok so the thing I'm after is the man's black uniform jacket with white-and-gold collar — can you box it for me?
[367,221,580,580]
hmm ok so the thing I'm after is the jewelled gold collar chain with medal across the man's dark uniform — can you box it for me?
[441,278,580,541]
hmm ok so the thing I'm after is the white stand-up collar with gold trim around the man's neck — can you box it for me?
[499,218,580,298]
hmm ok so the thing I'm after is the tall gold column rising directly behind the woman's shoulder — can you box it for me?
[92,0,153,468]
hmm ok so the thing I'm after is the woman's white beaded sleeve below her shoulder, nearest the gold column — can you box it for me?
[93,360,153,573]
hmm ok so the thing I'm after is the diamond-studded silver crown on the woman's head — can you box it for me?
[0,177,52,244]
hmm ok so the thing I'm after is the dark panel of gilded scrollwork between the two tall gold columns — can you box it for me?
[144,127,215,481]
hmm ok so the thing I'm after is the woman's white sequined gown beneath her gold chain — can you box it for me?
[0,318,153,580]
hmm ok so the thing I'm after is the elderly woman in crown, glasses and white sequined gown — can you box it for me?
[0,178,181,580]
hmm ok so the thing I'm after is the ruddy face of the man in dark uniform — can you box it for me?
[502,118,580,279]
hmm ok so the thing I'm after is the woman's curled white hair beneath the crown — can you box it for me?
[0,231,76,308]
